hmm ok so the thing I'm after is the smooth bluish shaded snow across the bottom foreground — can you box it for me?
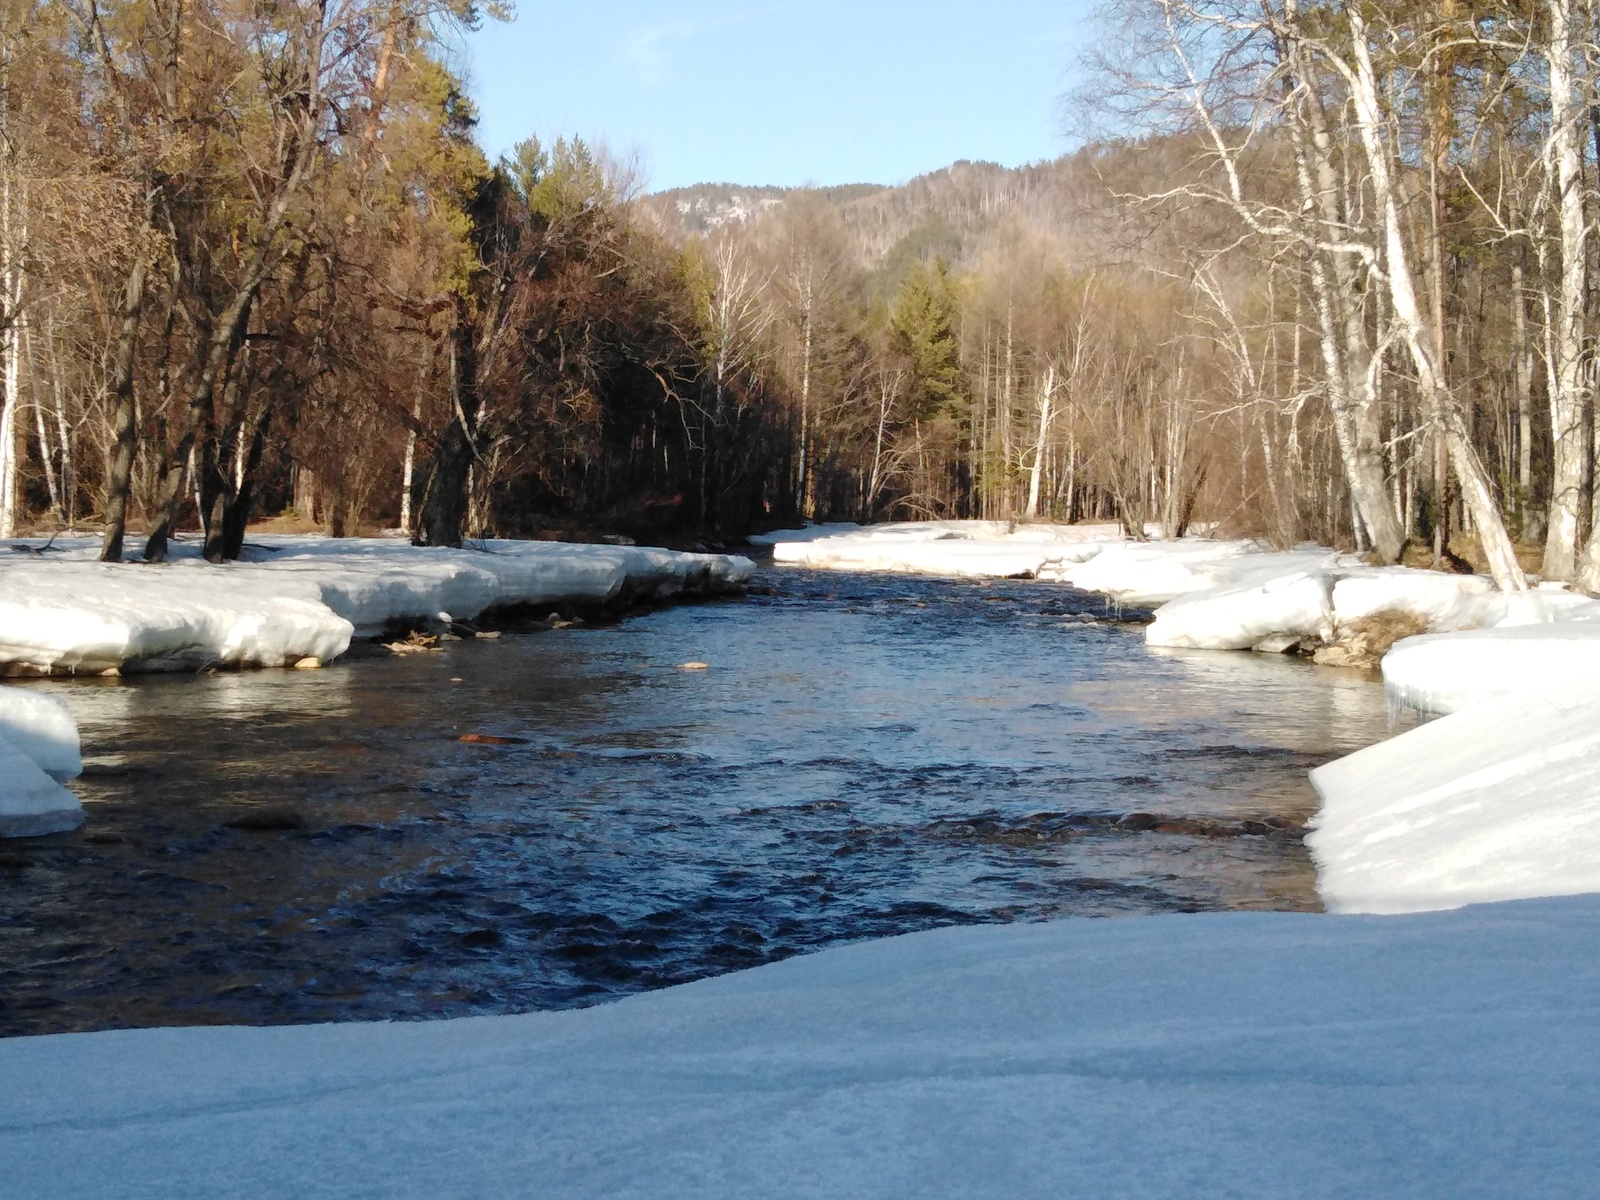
[0,898,1600,1200]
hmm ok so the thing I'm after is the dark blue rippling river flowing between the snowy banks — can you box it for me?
[0,571,1387,1034]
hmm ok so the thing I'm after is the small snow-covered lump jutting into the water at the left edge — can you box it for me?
[0,686,83,837]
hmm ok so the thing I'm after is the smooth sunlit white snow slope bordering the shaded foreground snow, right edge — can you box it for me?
[1307,686,1600,912]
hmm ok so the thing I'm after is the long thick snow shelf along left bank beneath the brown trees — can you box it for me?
[0,536,755,674]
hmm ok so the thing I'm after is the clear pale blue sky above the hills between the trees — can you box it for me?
[459,0,1093,190]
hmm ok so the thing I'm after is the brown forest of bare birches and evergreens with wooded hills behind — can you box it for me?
[9,0,1600,590]
